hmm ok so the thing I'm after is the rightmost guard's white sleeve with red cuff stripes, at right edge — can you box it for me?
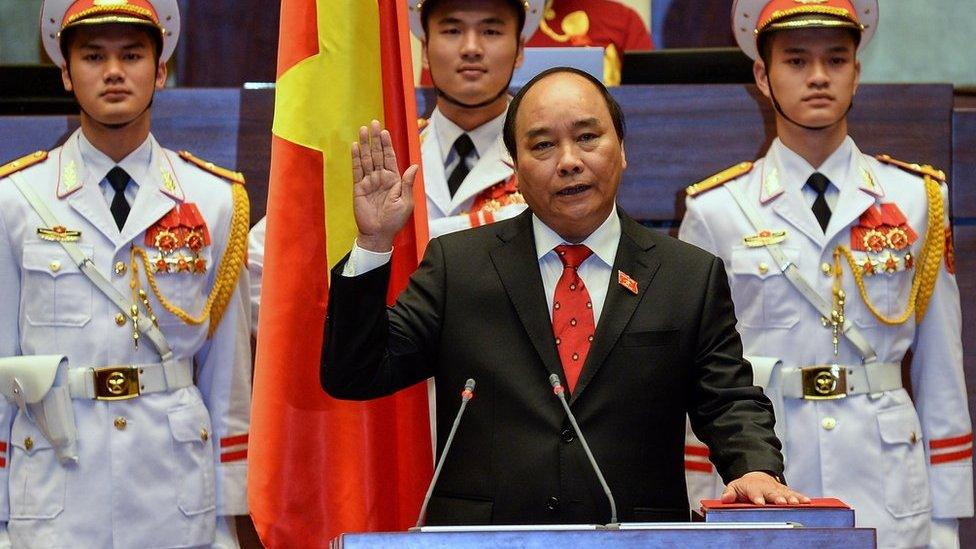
[911,183,973,518]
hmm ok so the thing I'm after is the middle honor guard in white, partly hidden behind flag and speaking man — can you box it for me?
[248,0,545,330]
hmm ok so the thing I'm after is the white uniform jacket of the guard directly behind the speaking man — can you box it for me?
[420,109,525,238]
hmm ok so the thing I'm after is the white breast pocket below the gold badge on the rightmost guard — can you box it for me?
[730,246,800,328]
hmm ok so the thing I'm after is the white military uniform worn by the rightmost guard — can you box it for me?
[679,137,973,547]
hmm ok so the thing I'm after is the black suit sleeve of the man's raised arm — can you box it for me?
[320,239,445,400]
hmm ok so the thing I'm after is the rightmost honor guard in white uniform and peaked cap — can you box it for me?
[679,0,973,548]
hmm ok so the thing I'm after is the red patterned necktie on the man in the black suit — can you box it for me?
[552,244,596,392]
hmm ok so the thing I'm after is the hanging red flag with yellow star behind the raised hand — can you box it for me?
[248,0,433,548]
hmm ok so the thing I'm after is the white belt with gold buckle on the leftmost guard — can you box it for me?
[68,359,193,400]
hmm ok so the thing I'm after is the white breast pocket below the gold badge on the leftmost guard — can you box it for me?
[21,242,94,327]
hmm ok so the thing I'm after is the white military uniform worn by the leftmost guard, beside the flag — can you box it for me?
[0,130,250,548]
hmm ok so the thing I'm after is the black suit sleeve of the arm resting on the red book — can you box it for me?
[688,258,783,483]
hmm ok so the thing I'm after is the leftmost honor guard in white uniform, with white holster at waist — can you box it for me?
[0,0,250,548]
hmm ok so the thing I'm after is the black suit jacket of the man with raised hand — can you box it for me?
[321,208,783,524]
